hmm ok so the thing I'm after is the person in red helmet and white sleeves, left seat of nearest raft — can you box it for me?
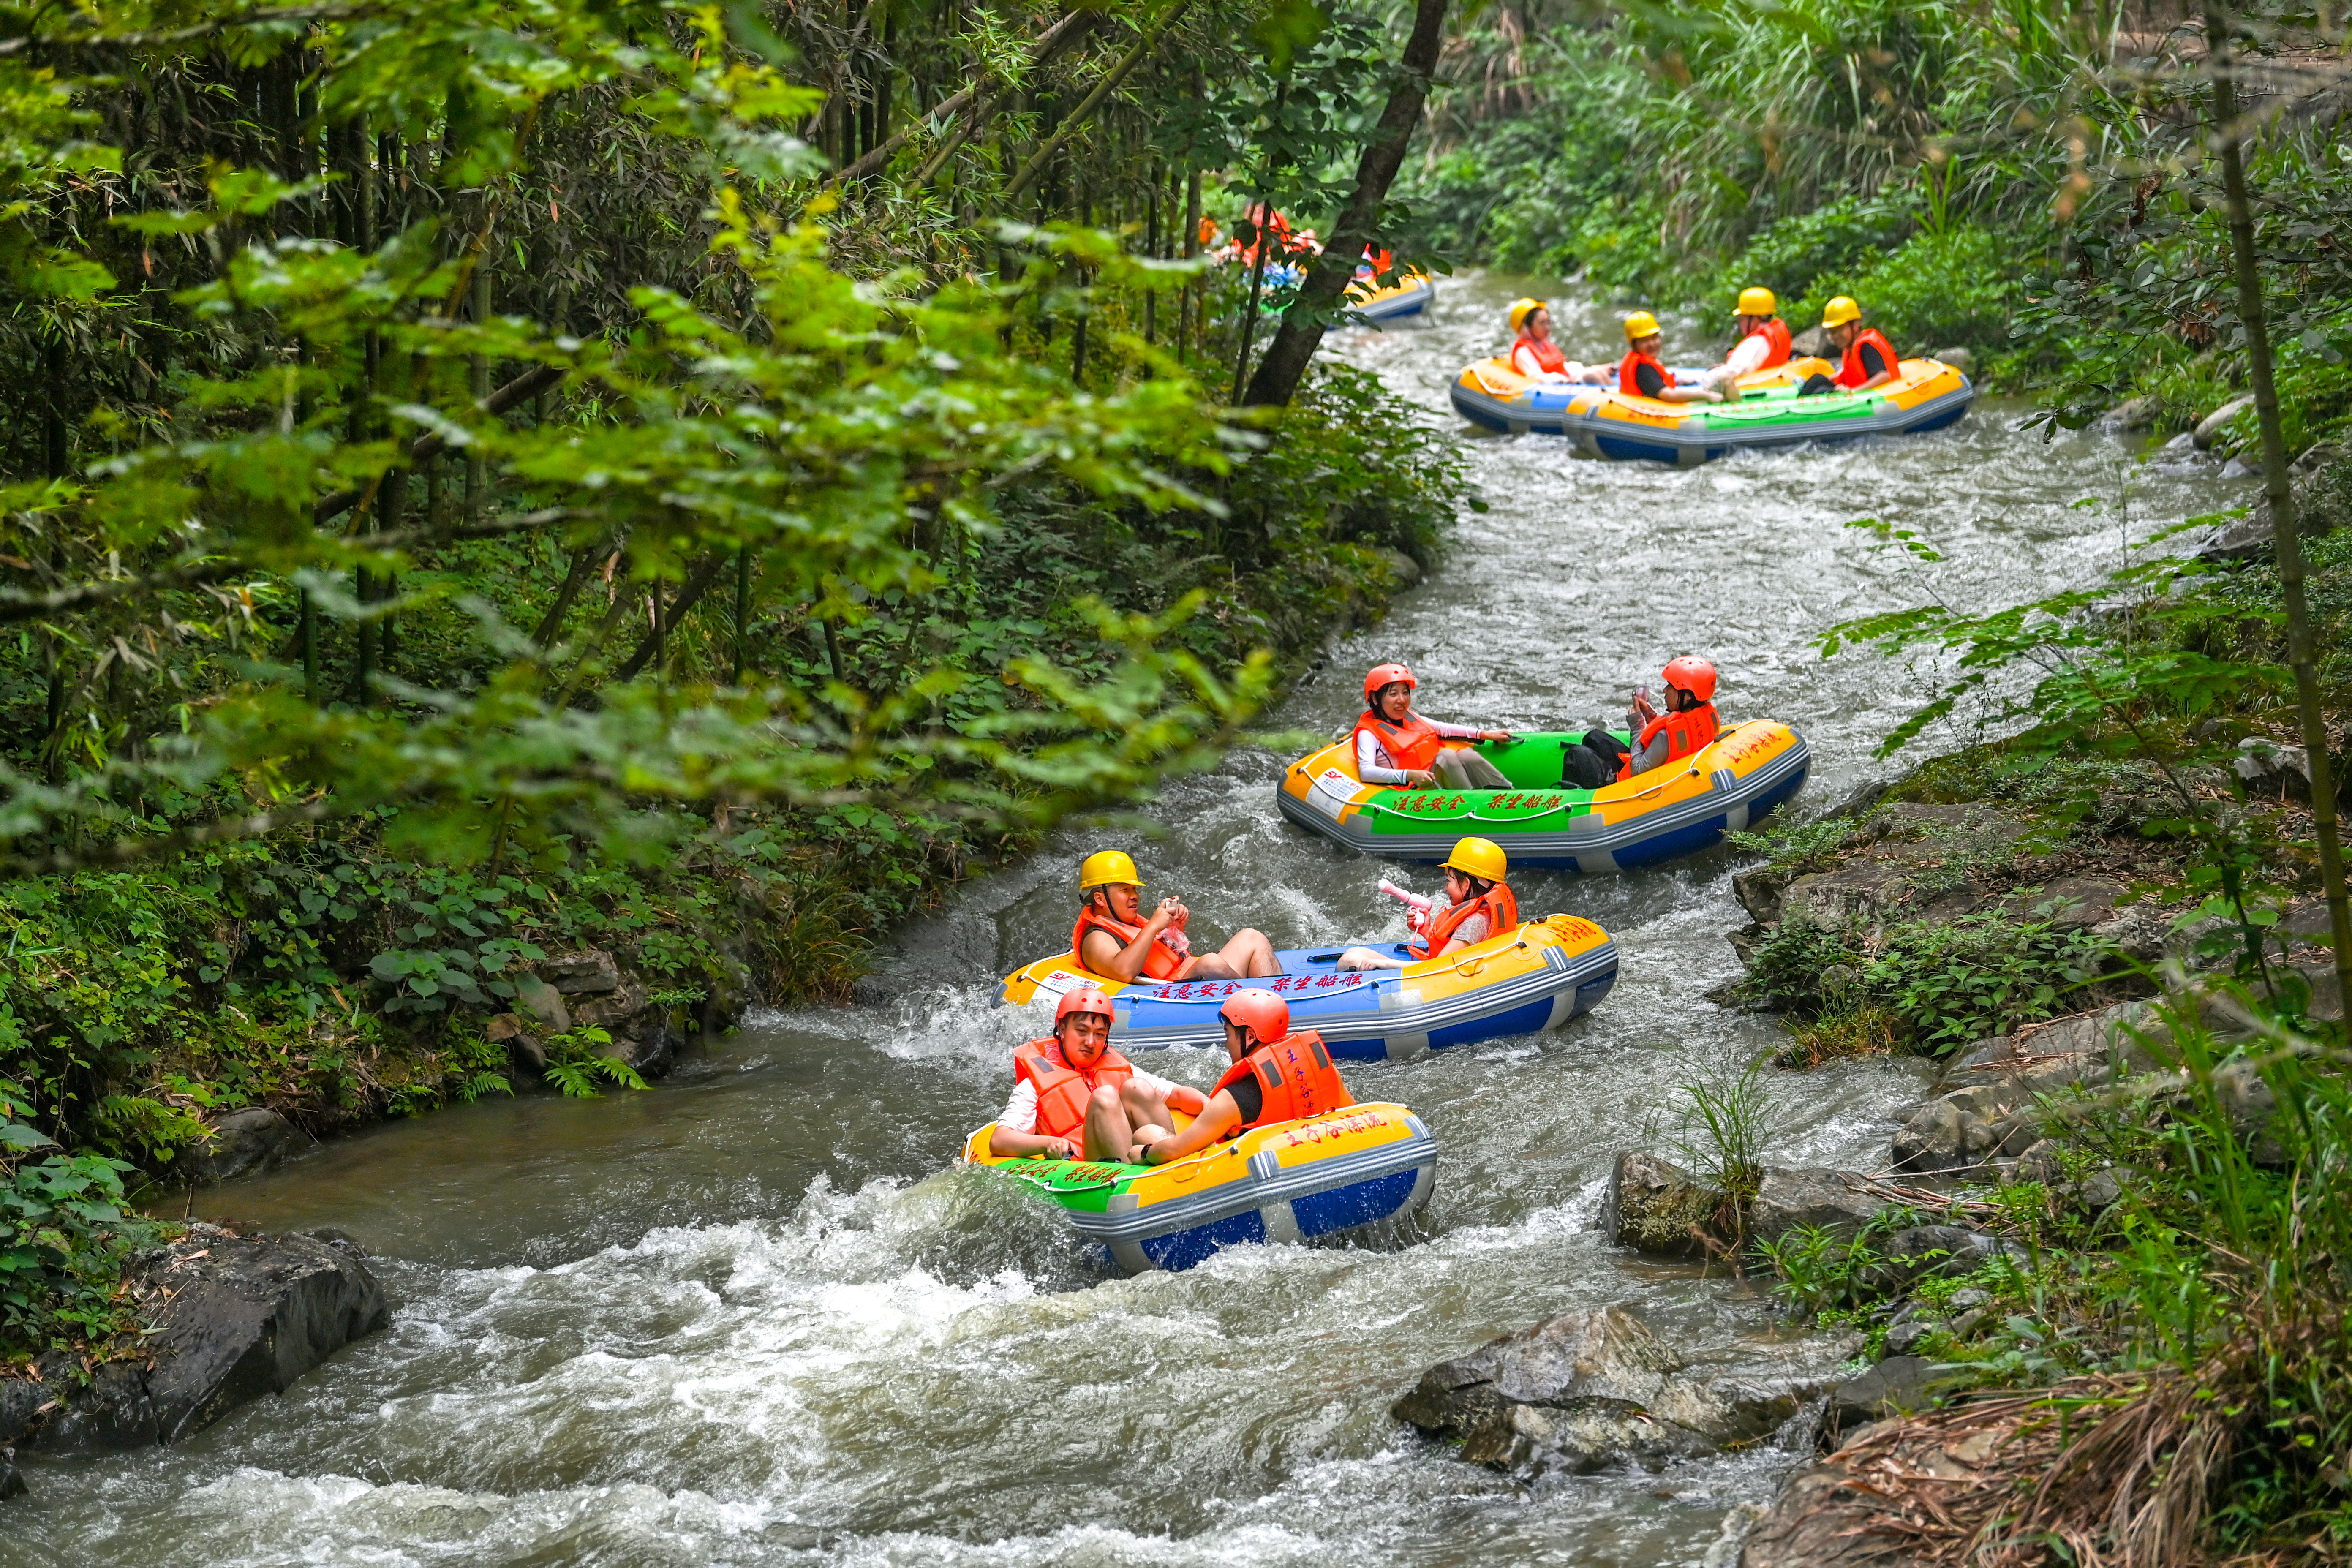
[988,985,1209,1161]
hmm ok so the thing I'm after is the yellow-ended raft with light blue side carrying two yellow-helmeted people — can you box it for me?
[1004,912,1616,1062]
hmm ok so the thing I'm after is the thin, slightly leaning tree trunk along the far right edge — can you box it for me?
[2206,5,2352,999]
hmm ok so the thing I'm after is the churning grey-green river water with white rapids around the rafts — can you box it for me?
[0,275,2249,1568]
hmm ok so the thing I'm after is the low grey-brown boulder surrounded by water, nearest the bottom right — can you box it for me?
[1395,1307,1818,1474]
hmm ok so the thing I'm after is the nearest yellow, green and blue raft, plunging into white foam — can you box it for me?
[964,1105,1437,1274]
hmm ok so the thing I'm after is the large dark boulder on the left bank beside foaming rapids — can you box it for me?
[18,1225,390,1453]
